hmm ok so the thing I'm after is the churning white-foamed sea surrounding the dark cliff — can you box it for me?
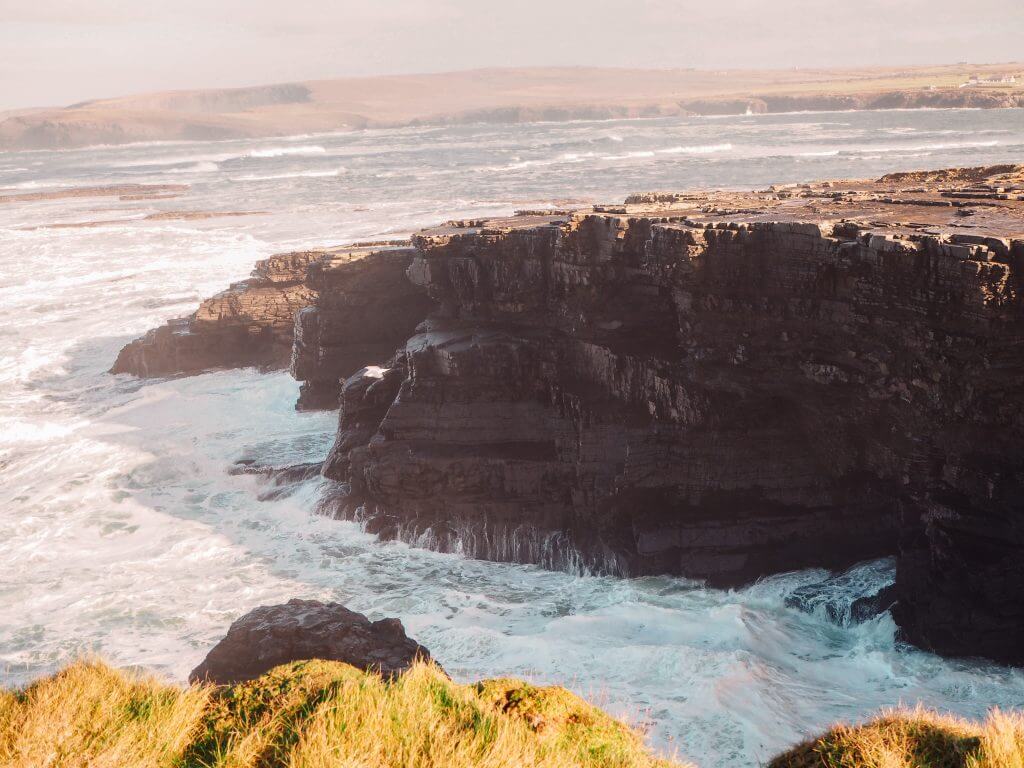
[0,111,1024,767]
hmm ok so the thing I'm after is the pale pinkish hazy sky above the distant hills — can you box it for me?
[0,0,1024,110]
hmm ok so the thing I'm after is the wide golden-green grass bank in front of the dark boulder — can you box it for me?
[0,660,679,768]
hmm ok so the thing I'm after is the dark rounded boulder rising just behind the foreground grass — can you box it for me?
[188,599,430,685]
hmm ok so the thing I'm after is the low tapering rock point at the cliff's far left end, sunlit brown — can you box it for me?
[111,243,433,409]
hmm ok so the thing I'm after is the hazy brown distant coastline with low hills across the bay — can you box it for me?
[0,62,1024,150]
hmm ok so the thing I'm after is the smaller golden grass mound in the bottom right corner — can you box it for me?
[769,708,1024,768]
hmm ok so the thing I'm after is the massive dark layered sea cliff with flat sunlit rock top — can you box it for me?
[112,166,1024,663]
